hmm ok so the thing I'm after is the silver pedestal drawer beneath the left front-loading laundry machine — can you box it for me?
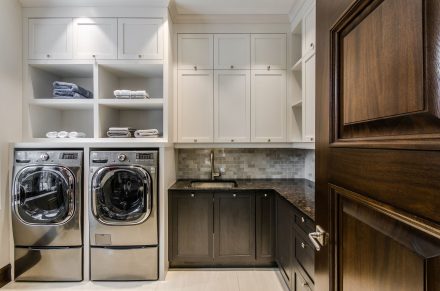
[15,247,83,282]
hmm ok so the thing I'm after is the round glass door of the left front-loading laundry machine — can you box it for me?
[13,166,75,224]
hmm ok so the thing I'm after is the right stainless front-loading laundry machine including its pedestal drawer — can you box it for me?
[90,150,158,281]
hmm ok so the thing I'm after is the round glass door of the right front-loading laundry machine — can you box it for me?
[92,166,152,225]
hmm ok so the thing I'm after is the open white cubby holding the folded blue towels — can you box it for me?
[25,64,94,101]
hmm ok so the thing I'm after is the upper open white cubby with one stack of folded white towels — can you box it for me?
[98,64,163,100]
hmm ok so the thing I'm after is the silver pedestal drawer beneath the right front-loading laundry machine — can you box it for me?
[90,246,159,281]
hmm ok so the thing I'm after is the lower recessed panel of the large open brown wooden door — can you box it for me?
[331,186,440,291]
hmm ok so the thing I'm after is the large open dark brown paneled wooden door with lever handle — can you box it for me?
[315,0,440,291]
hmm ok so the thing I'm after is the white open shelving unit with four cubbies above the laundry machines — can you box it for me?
[23,61,166,142]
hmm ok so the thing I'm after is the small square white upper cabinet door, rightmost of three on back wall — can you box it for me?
[251,34,287,70]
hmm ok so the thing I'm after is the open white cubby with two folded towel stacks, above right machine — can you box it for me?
[99,104,163,140]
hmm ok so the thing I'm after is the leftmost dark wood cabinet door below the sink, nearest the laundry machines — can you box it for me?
[169,192,214,267]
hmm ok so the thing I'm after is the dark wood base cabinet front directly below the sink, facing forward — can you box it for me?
[169,190,275,267]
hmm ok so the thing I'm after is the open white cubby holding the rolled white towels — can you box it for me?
[29,100,93,138]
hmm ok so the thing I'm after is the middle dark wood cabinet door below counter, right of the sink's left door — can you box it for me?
[214,192,255,266]
